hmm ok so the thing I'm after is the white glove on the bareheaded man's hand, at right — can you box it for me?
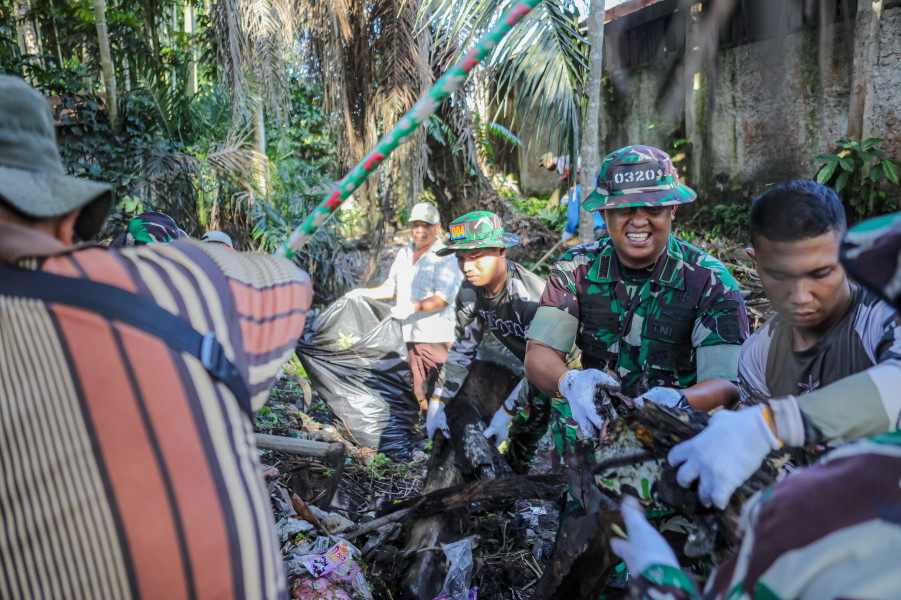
[667,406,781,509]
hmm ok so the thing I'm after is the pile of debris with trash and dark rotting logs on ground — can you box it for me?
[256,380,564,600]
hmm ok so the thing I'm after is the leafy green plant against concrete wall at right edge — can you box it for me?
[815,138,901,218]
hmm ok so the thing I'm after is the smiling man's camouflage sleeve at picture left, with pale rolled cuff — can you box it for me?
[526,264,579,353]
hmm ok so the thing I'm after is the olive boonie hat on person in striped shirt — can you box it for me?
[0,75,113,240]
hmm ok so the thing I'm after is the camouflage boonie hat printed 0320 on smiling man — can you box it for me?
[582,146,698,212]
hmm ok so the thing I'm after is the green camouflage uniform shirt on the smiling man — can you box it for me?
[528,235,748,396]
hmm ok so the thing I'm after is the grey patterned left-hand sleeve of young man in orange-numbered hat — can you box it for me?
[432,283,485,404]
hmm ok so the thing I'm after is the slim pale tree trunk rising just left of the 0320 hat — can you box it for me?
[570,0,606,244]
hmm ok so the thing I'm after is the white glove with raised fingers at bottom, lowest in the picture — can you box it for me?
[610,496,679,577]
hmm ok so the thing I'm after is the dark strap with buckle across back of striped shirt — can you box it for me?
[0,263,253,418]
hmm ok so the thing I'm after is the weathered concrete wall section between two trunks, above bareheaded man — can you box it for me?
[689,22,853,200]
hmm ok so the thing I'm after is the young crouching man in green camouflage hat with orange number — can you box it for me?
[426,211,576,473]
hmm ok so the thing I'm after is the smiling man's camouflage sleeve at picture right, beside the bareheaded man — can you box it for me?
[691,264,749,381]
